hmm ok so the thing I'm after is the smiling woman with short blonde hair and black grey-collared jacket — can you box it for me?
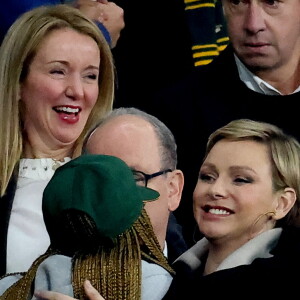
[164,119,300,300]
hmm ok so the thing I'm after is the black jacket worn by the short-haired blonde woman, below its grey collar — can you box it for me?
[163,228,300,300]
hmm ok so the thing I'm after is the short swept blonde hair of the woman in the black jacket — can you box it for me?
[205,119,300,226]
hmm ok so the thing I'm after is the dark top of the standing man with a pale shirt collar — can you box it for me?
[145,45,300,243]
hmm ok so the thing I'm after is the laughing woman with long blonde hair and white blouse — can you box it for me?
[0,5,114,275]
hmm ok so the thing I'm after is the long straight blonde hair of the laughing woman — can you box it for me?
[0,5,115,196]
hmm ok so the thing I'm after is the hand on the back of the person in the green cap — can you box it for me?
[34,280,105,300]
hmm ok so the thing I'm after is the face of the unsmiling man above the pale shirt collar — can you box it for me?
[223,0,300,71]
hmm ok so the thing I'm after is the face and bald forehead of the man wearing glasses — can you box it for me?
[87,115,171,244]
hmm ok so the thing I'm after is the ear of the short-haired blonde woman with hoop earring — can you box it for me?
[273,187,297,220]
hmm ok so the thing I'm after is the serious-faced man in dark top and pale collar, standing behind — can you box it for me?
[144,0,300,244]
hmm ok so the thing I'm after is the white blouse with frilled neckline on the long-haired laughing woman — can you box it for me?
[6,157,71,273]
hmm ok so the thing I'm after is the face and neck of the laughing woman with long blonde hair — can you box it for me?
[20,28,100,145]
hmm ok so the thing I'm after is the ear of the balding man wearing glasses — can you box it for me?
[168,169,184,211]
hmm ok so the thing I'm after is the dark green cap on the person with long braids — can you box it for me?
[42,154,159,246]
